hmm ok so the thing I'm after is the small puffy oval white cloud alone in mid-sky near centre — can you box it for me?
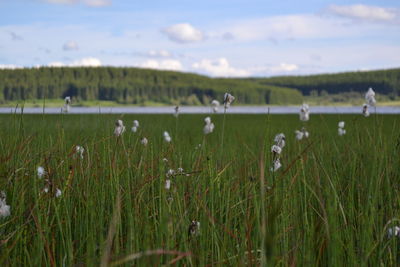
[162,23,204,43]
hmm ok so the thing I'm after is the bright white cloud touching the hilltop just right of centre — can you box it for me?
[192,58,250,77]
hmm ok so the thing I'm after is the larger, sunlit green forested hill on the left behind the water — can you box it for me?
[0,67,302,105]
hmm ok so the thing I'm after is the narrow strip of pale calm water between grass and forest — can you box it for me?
[0,106,400,114]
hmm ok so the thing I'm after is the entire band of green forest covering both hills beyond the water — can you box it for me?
[0,67,400,105]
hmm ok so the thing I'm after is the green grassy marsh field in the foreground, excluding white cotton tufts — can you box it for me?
[0,110,400,266]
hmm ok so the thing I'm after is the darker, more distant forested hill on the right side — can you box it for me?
[246,69,400,98]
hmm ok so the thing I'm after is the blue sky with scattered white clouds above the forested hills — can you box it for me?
[0,0,400,77]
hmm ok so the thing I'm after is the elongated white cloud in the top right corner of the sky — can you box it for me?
[328,4,396,21]
